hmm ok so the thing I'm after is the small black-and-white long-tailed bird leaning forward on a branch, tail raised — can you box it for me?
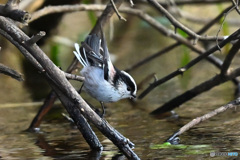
[73,30,137,116]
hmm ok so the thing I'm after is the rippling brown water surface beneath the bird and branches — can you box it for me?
[0,96,240,160]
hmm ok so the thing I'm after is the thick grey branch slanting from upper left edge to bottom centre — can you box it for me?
[0,16,139,159]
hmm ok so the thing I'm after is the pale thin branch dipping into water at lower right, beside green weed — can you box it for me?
[166,98,240,143]
